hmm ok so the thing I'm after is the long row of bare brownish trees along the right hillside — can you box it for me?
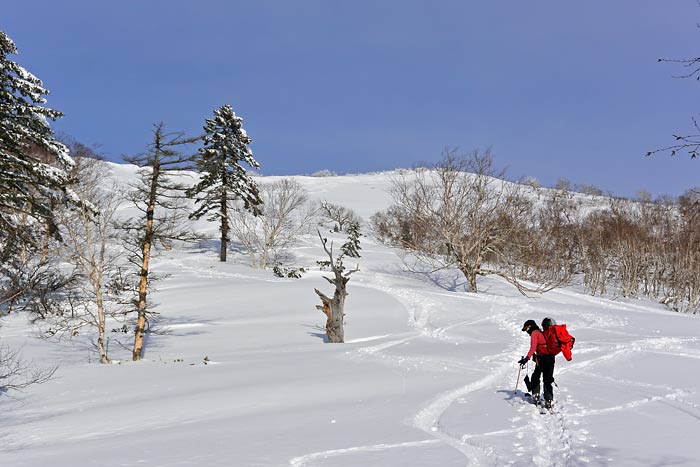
[371,149,700,312]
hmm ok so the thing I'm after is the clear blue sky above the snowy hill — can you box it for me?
[5,0,700,196]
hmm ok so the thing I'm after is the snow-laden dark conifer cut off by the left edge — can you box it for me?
[0,31,72,261]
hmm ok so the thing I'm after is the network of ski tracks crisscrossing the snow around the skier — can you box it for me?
[290,266,700,467]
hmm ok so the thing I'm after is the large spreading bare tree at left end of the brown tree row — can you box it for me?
[392,149,541,292]
